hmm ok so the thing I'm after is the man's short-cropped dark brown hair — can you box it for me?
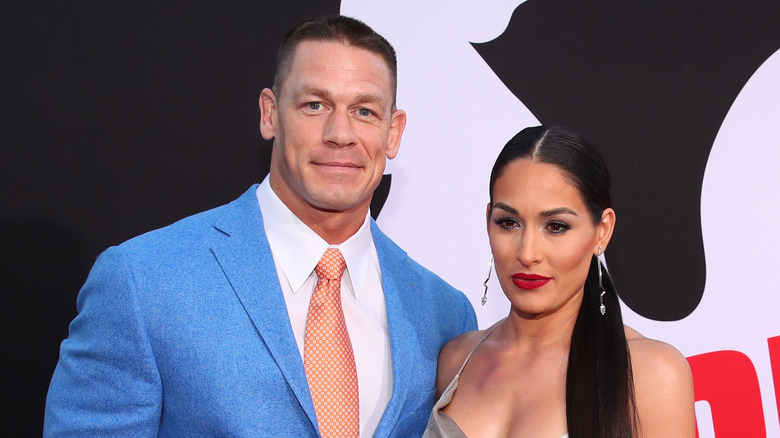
[272,15,398,108]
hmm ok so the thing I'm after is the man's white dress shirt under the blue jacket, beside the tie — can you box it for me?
[257,177,393,437]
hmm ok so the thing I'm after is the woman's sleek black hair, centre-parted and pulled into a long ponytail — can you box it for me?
[490,126,639,438]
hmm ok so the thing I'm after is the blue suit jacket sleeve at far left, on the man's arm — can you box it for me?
[44,248,162,437]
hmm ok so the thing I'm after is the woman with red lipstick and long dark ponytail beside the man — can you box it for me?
[425,126,696,438]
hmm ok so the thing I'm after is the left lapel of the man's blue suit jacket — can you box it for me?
[212,185,317,427]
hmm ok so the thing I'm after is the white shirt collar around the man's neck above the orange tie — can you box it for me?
[256,176,376,300]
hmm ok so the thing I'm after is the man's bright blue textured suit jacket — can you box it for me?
[44,186,476,437]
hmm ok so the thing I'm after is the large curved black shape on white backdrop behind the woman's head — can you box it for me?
[474,0,780,321]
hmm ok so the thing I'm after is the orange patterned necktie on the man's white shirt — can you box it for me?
[303,248,360,438]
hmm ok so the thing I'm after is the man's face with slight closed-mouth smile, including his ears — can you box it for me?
[260,41,406,216]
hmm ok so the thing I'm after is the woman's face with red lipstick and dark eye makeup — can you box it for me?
[487,159,615,317]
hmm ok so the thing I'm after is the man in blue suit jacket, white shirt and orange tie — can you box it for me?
[44,17,476,437]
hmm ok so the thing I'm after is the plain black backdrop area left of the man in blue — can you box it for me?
[0,0,340,436]
